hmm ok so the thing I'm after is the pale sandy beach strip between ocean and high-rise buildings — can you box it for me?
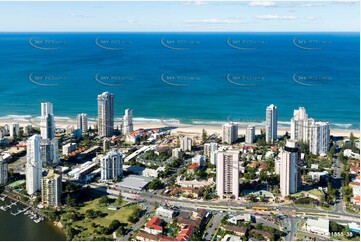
[0,118,360,138]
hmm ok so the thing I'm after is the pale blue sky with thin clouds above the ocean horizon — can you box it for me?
[0,1,360,32]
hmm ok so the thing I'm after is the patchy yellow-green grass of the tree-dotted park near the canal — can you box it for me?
[61,198,138,240]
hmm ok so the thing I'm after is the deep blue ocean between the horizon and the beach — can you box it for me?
[0,33,360,129]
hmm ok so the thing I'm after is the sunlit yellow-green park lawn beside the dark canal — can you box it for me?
[61,198,138,240]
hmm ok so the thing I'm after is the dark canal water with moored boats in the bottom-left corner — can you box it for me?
[0,199,66,241]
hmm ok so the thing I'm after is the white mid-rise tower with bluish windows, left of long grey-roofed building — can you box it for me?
[100,151,123,181]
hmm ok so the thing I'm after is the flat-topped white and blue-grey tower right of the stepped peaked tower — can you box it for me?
[309,122,330,155]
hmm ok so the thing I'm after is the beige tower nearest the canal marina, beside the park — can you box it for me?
[41,170,62,207]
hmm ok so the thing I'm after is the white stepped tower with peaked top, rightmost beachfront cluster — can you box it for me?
[291,107,314,142]
